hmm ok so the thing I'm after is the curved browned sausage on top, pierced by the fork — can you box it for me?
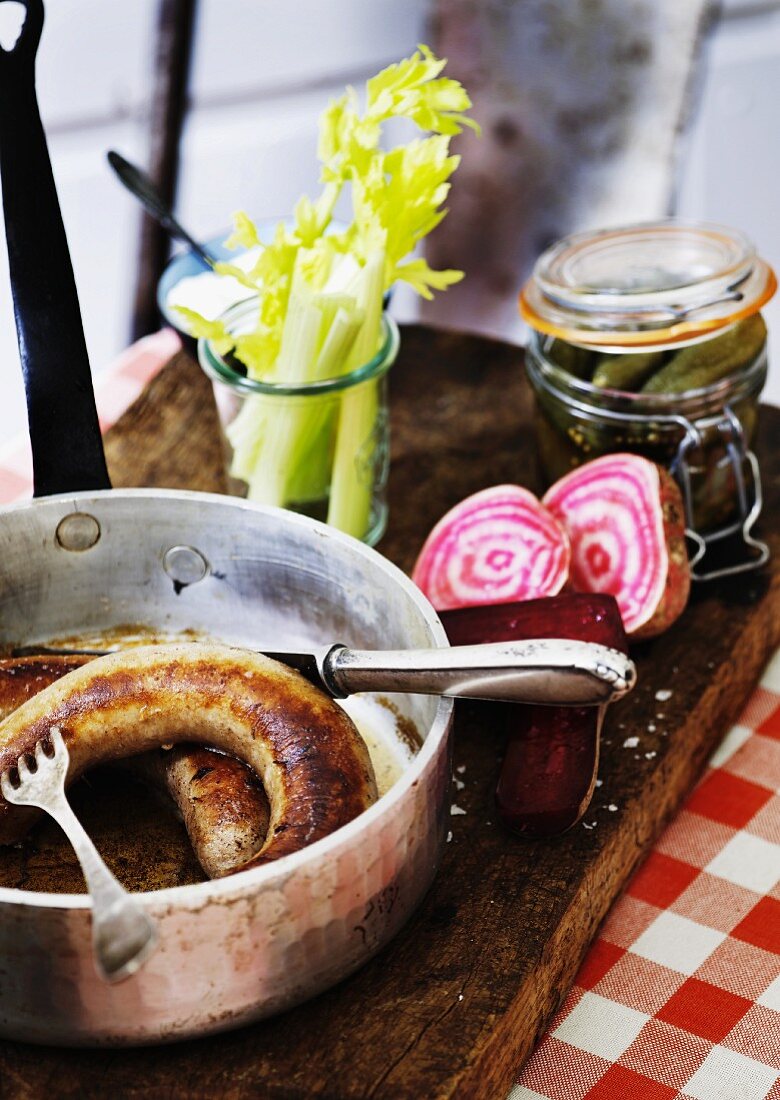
[0,642,376,869]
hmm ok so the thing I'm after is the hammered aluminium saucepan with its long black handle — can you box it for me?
[0,0,624,1045]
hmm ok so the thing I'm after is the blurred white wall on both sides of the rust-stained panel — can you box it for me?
[0,0,780,447]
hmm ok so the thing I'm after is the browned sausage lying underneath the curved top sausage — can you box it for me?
[0,656,270,879]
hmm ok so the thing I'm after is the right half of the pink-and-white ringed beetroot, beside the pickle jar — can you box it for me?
[543,454,691,638]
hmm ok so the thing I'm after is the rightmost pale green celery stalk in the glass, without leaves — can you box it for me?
[328,251,385,539]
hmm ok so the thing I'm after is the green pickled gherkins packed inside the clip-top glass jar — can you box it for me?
[526,315,766,534]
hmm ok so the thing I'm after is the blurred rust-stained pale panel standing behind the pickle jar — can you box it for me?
[424,0,715,338]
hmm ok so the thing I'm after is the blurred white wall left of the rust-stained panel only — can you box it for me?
[0,0,428,448]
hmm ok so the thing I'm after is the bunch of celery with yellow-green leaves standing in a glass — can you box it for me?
[179,46,475,538]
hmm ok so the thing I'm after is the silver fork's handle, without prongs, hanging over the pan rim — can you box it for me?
[45,794,157,982]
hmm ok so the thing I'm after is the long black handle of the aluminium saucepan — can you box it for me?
[0,0,111,496]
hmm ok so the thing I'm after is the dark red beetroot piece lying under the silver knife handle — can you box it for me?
[441,594,628,838]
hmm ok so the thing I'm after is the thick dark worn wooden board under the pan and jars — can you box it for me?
[0,328,780,1100]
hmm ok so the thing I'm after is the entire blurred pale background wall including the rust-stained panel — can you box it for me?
[0,0,780,447]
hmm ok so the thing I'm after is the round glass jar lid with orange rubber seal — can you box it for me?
[520,219,777,347]
